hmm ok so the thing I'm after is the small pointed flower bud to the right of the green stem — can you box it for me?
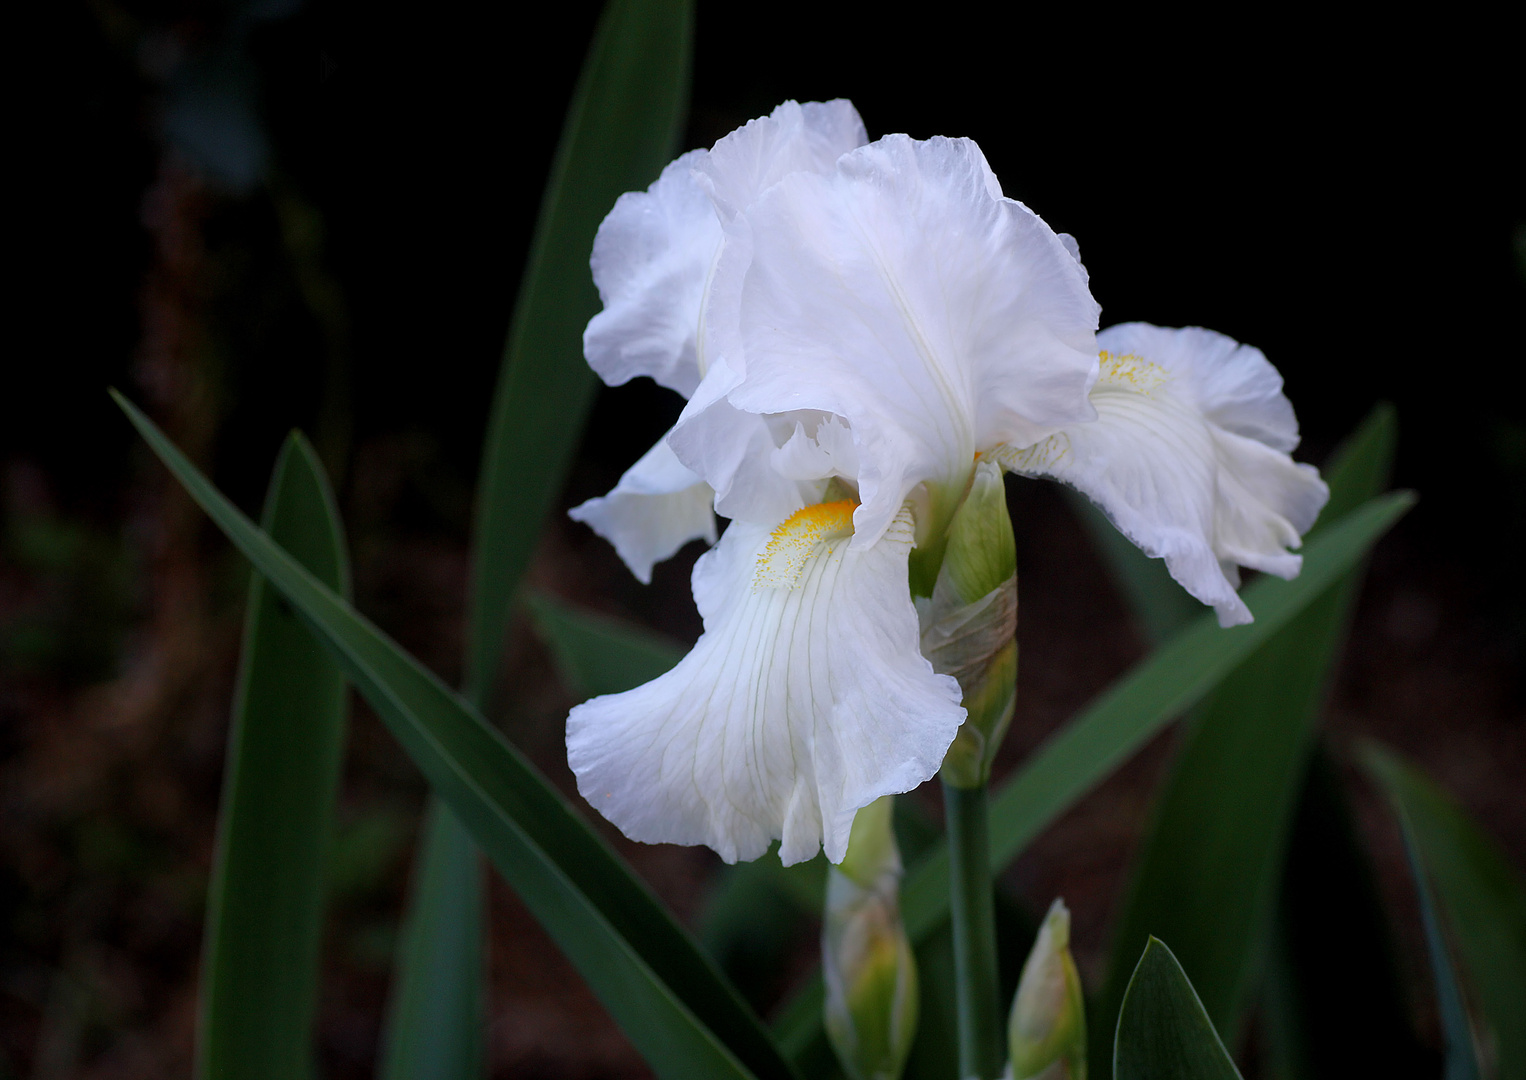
[1007,900,1087,1080]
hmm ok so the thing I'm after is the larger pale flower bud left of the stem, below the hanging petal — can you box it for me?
[821,795,917,1080]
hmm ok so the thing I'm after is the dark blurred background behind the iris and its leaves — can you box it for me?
[0,0,1526,1077]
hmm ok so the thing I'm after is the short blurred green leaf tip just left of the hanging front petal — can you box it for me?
[525,593,687,697]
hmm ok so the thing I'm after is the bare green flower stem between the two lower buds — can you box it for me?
[943,781,1003,1080]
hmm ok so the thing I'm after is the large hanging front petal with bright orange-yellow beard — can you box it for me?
[568,502,964,865]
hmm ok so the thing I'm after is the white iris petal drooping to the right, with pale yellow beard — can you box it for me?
[996,323,1329,627]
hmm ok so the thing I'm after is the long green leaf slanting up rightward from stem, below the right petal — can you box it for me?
[775,491,1415,1046]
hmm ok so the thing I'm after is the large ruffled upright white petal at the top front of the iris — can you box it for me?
[673,136,1097,546]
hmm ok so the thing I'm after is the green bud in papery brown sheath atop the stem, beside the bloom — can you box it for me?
[917,461,1018,787]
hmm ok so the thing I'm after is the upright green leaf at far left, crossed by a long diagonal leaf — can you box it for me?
[197,432,349,1080]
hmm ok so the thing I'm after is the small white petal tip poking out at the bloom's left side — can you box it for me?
[568,435,716,584]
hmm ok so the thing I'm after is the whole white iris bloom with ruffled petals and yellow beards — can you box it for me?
[568,101,1325,863]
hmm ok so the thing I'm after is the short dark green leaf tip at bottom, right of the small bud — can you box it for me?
[1112,938,1241,1080]
